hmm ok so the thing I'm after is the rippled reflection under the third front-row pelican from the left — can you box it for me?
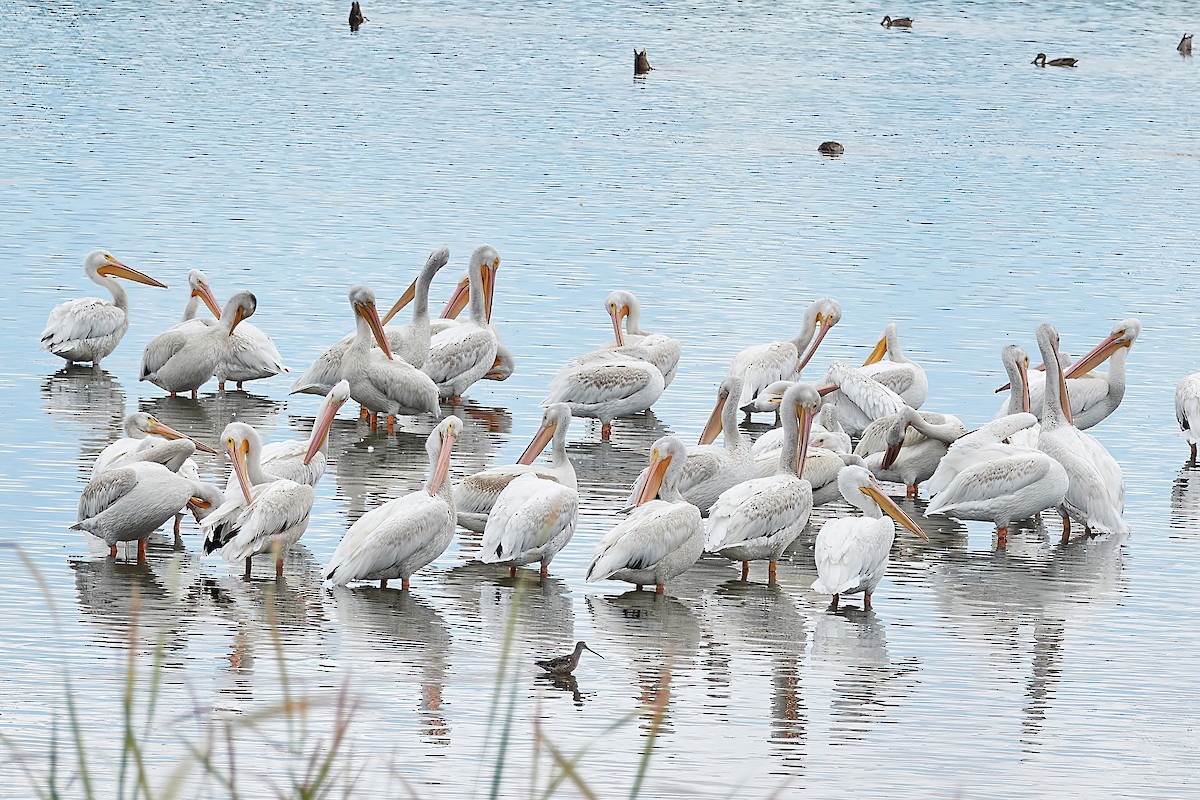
[332,585,451,746]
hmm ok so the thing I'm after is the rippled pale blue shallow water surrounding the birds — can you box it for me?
[0,1,1200,798]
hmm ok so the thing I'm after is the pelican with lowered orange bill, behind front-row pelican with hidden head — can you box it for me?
[454,403,576,533]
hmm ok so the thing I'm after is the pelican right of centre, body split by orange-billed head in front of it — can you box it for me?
[625,378,753,515]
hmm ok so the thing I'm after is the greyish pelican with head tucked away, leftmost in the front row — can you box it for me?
[71,448,211,561]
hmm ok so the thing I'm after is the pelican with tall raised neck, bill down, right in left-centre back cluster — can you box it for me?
[421,245,500,403]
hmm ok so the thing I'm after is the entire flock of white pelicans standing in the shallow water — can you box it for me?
[42,246,1200,604]
